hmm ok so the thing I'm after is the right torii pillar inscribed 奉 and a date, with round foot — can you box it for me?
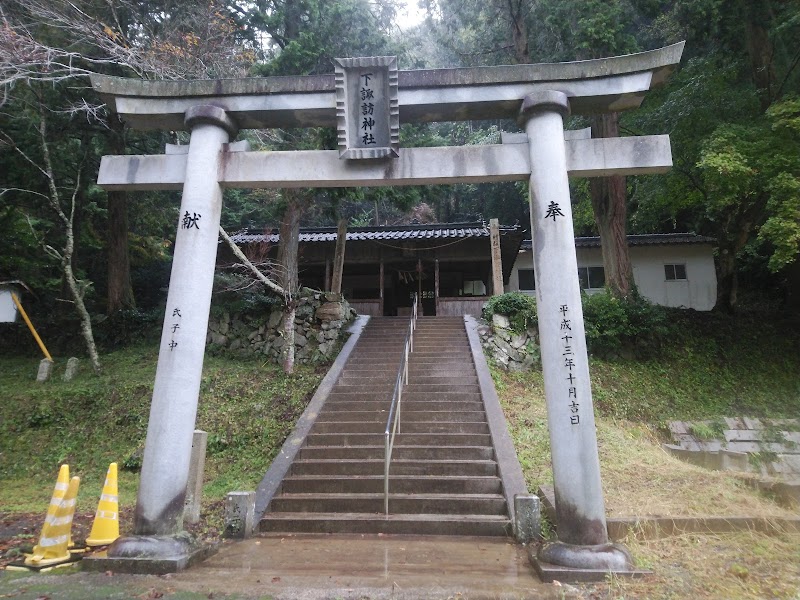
[519,91,632,572]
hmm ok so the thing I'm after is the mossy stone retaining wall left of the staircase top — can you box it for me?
[206,289,356,363]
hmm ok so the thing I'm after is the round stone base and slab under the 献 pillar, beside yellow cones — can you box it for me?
[82,532,218,575]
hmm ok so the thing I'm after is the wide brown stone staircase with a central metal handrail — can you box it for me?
[260,317,511,536]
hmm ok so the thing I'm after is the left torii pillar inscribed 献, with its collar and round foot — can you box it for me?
[108,105,238,570]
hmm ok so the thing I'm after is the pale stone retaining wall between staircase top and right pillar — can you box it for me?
[478,315,541,371]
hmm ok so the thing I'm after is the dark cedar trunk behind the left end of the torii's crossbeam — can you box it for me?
[106,117,136,314]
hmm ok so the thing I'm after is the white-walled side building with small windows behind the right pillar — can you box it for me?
[506,233,717,310]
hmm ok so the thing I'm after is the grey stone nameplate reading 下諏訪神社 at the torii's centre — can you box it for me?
[334,56,400,159]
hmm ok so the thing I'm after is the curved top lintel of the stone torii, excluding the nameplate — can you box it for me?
[91,42,684,130]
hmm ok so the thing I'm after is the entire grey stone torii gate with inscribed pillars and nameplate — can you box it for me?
[92,43,683,570]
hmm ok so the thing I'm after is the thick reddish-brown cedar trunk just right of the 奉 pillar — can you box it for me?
[589,113,636,298]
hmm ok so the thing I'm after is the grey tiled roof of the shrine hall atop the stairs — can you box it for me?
[231,223,521,244]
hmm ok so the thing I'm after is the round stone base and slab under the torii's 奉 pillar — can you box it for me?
[528,542,651,583]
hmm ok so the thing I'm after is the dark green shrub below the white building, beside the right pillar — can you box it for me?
[583,293,670,356]
